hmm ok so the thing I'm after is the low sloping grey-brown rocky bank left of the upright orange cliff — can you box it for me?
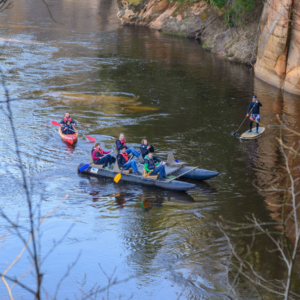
[118,0,263,66]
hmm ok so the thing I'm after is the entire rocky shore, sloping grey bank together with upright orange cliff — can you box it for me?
[117,0,300,95]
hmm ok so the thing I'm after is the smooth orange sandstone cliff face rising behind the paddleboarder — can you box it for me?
[255,0,300,95]
